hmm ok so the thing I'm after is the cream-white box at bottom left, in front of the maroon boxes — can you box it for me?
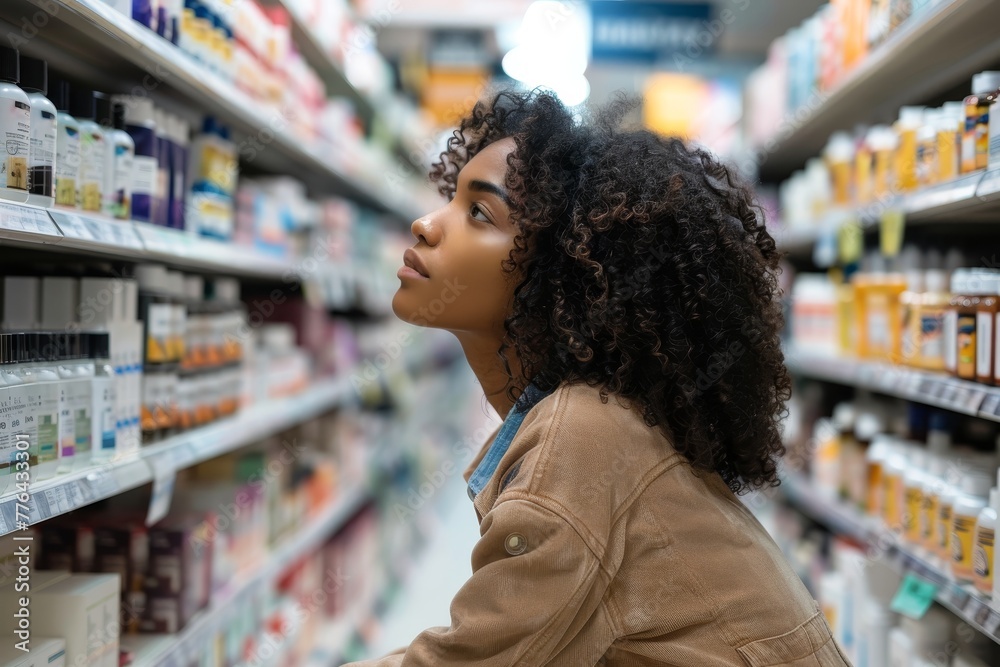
[31,572,121,667]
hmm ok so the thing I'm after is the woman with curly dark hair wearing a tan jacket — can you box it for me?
[346,92,849,667]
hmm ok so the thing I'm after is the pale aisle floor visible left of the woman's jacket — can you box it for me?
[369,476,479,657]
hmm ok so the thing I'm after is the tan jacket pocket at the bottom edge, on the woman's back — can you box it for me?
[736,611,851,667]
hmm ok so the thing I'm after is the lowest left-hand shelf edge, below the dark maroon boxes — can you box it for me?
[129,488,371,667]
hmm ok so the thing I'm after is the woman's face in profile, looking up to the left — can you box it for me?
[392,139,517,336]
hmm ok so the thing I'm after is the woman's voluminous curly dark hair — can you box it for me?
[430,91,791,493]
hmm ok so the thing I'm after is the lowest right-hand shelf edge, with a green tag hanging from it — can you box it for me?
[778,473,1000,643]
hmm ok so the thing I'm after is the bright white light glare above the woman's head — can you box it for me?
[501,0,590,106]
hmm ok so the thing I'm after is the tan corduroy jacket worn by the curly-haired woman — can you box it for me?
[346,384,850,667]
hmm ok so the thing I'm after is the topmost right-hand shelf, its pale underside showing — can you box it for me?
[759,0,1000,181]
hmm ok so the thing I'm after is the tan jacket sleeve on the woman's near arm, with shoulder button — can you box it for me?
[340,499,614,667]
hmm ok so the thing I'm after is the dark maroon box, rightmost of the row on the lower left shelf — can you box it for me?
[141,514,212,633]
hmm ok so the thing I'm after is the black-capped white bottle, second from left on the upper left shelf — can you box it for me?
[21,56,58,208]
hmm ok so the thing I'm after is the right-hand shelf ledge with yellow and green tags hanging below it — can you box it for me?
[775,169,1000,255]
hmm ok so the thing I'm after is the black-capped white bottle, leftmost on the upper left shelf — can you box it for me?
[0,46,31,202]
